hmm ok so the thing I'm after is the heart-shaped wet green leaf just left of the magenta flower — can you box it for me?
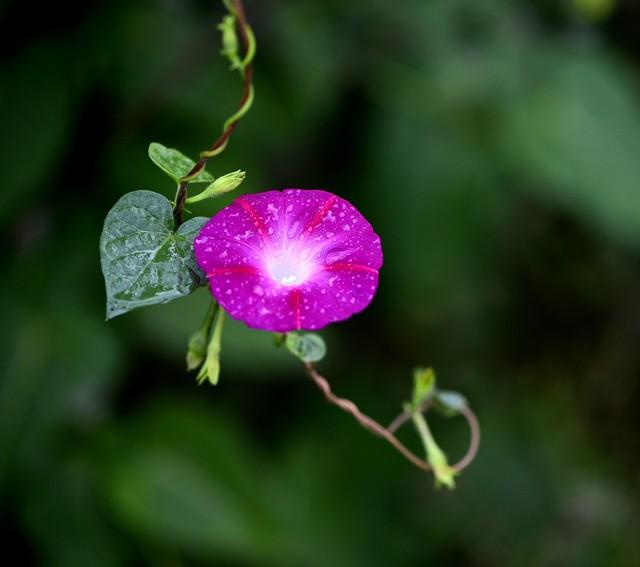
[100,191,208,319]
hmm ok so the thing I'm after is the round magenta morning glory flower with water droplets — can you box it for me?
[194,189,382,332]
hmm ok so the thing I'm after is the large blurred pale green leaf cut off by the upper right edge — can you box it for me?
[503,49,640,246]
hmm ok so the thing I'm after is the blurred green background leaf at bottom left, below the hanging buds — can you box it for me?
[100,402,274,565]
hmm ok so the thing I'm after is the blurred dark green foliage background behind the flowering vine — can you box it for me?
[0,0,640,566]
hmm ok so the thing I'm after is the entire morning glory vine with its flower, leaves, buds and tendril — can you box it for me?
[100,0,480,488]
